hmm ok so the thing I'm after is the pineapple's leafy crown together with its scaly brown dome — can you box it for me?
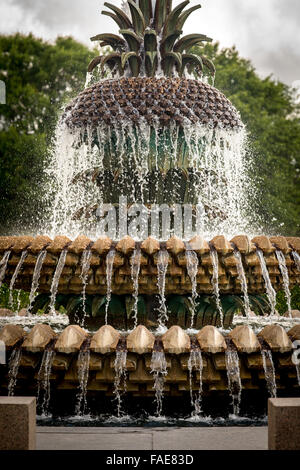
[63,0,242,130]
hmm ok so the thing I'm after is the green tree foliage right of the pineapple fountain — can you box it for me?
[194,44,300,236]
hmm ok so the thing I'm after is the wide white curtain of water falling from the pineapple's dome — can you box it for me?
[43,119,251,238]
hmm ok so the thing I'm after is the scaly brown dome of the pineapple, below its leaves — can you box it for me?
[64,77,242,130]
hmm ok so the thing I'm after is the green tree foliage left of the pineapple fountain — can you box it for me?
[0,34,93,235]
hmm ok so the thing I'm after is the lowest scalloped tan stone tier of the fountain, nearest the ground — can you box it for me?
[0,324,300,396]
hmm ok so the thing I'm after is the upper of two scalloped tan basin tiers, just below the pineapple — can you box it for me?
[0,235,300,295]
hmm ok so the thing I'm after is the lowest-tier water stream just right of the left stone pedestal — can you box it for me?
[37,349,55,416]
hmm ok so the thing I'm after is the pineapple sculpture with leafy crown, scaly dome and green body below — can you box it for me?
[63,0,242,218]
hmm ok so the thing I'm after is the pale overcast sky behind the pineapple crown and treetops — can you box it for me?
[0,0,300,84]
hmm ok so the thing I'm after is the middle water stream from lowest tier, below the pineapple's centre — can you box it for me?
[150,351,168,417]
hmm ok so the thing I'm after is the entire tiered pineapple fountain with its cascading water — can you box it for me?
[0,0,300,418]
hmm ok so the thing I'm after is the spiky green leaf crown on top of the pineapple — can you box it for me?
[89,0,215,77]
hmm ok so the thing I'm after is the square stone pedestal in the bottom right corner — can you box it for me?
[268,398,300,450]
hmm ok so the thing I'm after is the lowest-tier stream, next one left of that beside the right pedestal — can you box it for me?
[225,347,242,416]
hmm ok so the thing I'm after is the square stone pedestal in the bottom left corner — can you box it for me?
[0,397,36,450]
